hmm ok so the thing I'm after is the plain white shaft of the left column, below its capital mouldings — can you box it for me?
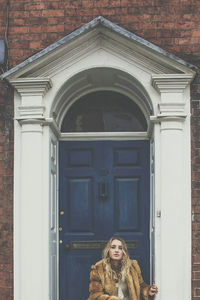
[20,120,45,300]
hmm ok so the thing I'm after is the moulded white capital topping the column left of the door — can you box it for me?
[10,78,52,97]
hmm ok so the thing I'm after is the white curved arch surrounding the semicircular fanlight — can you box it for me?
[50,67,154,137]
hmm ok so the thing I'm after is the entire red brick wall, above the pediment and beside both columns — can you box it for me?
[0,0,200,300]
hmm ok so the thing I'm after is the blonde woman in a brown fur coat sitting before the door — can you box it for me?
[88,237,158,300]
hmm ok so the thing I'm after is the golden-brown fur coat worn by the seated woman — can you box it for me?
[88,260,152,300]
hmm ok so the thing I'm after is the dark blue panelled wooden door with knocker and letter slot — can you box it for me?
[59,141,150,300]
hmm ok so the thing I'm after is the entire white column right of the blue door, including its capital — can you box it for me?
[152,74,192,300]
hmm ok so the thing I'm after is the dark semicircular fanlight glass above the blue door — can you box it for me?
[61,91,147,132]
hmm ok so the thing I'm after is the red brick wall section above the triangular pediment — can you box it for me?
[1,0,200,66]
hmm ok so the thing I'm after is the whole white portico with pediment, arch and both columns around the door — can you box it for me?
[2,17,195,300]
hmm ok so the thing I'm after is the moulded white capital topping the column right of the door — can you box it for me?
[152,74,194,94]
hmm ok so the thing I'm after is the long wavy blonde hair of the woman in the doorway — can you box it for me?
[103,237,131,281]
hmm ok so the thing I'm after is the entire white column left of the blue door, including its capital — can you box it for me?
[11,79,51,300]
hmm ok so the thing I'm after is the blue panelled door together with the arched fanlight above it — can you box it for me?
[59,90,150,300]
